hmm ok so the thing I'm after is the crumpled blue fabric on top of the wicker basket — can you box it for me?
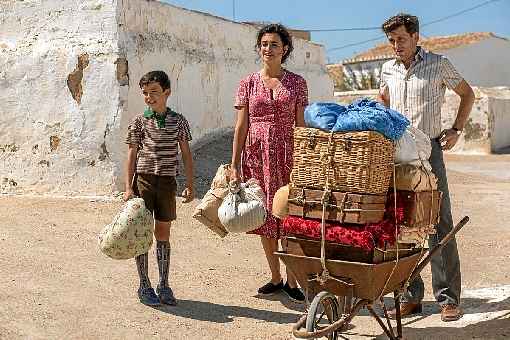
[305,98,409,140]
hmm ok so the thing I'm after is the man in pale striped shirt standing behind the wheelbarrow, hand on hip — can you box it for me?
[378,14,474,321]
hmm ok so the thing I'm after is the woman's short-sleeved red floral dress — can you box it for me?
[235,70,308,239]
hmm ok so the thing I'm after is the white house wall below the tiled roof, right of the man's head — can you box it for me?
[438,37,510,87]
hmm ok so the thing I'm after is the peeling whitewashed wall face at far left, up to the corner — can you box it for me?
[0,0,119,194]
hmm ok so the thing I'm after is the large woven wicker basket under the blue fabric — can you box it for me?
[291,127,394,194]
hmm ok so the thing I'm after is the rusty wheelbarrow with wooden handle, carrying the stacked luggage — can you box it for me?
[275,216,469,340]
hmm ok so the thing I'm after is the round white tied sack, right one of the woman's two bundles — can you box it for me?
[218,179,267,233]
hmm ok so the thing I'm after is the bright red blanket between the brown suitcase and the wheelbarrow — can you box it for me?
[283,216,395,251]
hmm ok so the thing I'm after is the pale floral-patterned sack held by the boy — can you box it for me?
[98,197,154,260]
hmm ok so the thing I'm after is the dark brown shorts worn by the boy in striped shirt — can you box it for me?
[136,174,177,222]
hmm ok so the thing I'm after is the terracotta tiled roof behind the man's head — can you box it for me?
[342,32,496,64]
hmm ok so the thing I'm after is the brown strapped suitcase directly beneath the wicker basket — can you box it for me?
[288,187,386,224]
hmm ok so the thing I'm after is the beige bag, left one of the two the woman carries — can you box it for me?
[192,164,230,237]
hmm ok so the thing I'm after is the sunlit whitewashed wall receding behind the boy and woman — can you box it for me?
[120,0,333,139]
